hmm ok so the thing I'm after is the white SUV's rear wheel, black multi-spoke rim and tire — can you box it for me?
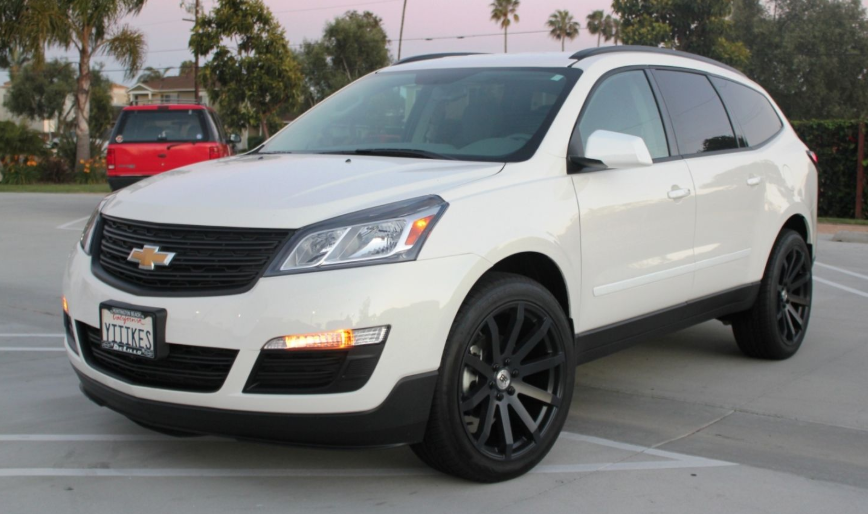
[732,229,813,360]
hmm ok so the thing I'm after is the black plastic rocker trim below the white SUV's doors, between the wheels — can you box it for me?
[576,282,760,363]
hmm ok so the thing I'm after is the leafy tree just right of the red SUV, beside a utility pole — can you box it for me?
[190,0,302,137]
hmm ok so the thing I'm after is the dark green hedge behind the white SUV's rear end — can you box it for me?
[793,120,868,219]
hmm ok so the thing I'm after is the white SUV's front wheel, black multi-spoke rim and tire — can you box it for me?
[412,273,575,483]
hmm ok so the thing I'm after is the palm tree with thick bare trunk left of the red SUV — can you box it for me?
[22,0,147,162]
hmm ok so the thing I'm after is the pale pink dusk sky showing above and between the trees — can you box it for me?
[0,0,868,84]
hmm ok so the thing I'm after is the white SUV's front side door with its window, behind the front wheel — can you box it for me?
[571,69,696,332]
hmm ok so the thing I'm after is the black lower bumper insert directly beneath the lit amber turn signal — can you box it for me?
[244,344,383,394]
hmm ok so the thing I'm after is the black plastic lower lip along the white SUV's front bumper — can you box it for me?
[76,370,437,448]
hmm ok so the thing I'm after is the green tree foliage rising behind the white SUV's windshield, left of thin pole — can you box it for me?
[298,11,391,107]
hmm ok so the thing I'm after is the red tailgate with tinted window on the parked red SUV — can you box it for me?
[112,107,214,175]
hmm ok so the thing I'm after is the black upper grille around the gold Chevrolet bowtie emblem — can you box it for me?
[97,216,293,296]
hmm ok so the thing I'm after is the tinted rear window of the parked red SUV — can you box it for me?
[112,109,210,143]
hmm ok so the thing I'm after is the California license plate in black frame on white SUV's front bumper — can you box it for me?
[100,304,160,359]
